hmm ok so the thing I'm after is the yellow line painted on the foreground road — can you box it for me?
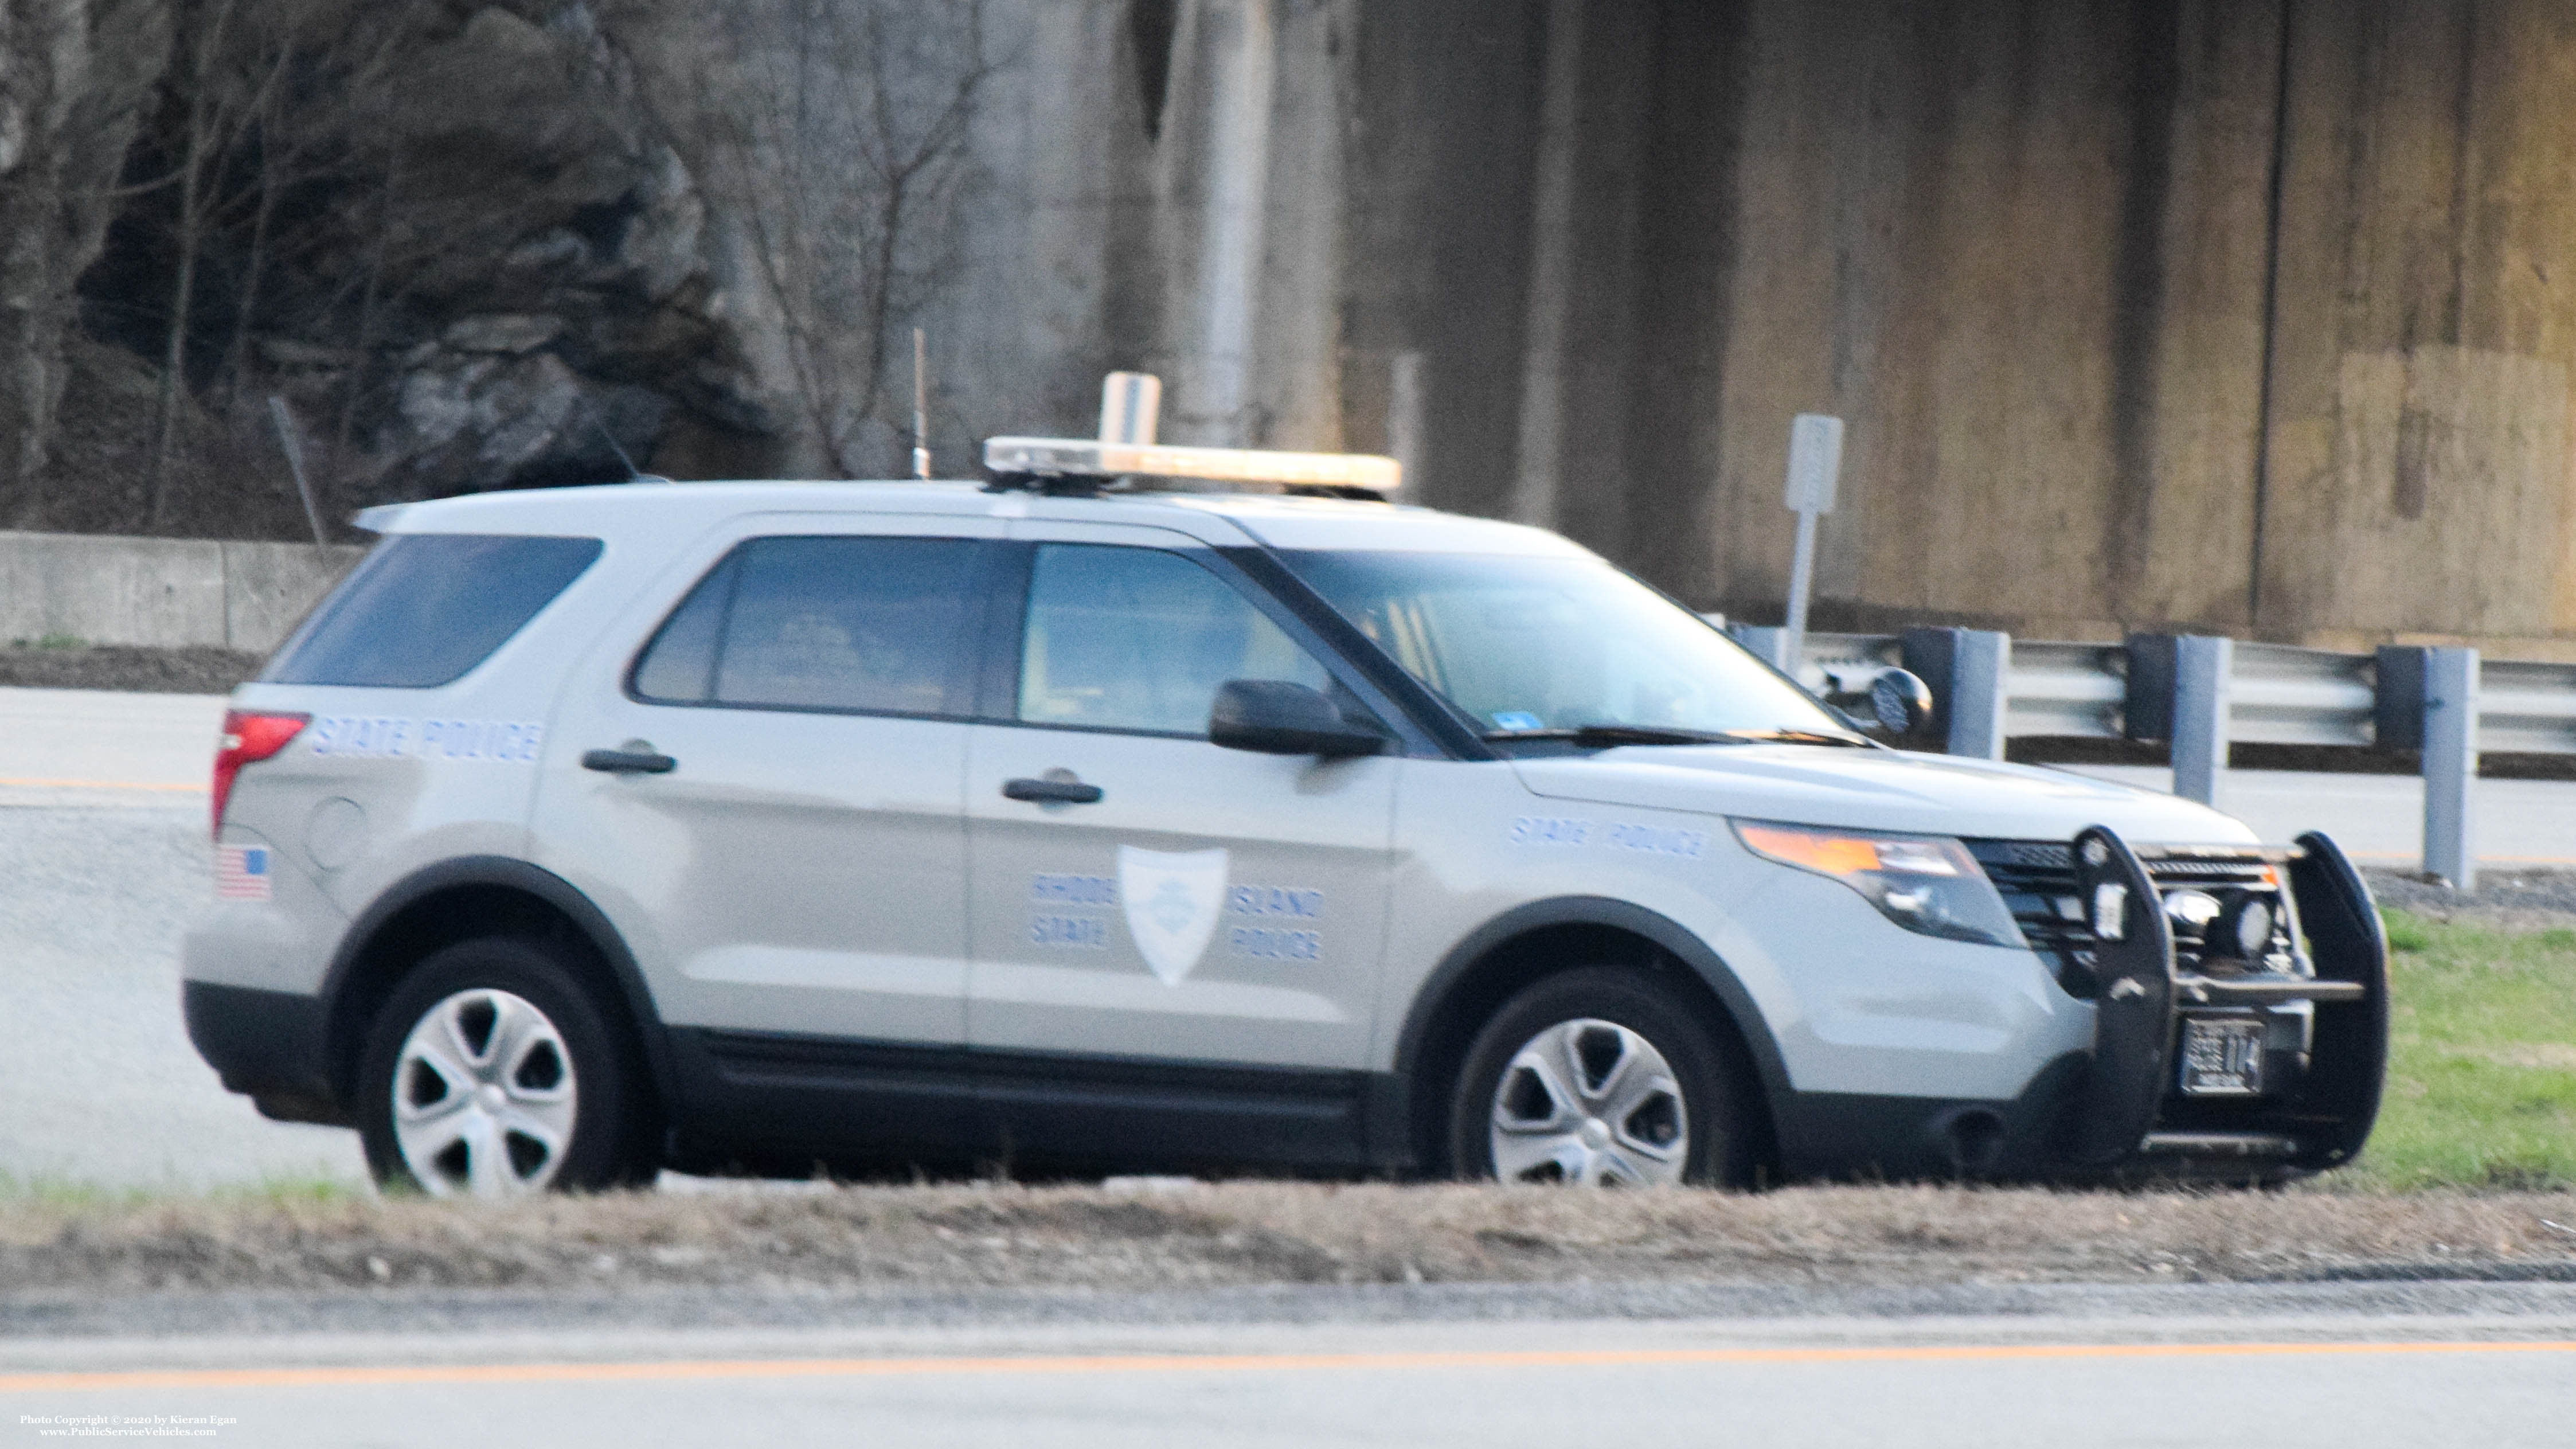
[0,1341,2576,1392]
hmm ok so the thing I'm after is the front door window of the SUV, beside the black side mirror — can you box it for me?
[1020,544,1332,737]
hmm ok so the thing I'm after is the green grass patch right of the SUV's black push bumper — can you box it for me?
[2359,910,2576,1189]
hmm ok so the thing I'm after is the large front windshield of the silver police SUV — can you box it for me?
[1283,552,1855,743]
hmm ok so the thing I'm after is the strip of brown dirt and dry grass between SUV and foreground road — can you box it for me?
[0,1184,2576,1299]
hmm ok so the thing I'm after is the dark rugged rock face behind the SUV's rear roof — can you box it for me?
[335,5,760,495]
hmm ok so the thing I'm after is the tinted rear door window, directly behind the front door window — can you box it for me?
[628,536,979,714]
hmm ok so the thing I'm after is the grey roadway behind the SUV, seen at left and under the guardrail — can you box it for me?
[0,689,2576,1186]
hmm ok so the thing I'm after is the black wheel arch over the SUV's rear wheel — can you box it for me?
[322,856,678,1119]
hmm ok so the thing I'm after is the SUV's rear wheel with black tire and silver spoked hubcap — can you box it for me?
[358,936,659,1199]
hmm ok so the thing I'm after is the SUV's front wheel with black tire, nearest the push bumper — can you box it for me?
[1451,967,1754,1186]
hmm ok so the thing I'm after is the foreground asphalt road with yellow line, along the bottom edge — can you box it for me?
[0,1299,2576,1449]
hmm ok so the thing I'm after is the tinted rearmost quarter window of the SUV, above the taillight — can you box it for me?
[260,534,600,689]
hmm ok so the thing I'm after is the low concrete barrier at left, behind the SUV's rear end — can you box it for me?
[0,531,366,655]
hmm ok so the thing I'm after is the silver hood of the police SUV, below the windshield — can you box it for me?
[1512,745,2257,846]
